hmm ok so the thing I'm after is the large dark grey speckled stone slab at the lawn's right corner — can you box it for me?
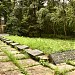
[49,50,75,64]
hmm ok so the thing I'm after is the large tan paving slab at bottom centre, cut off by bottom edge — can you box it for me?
[27,65,54,75]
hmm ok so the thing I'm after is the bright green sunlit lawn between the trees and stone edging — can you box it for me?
[6,36,75,54]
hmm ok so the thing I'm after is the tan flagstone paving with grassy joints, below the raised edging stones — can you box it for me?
[0,41,75,75]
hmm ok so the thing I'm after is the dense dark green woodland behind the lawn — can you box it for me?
[0,0,75,37]
